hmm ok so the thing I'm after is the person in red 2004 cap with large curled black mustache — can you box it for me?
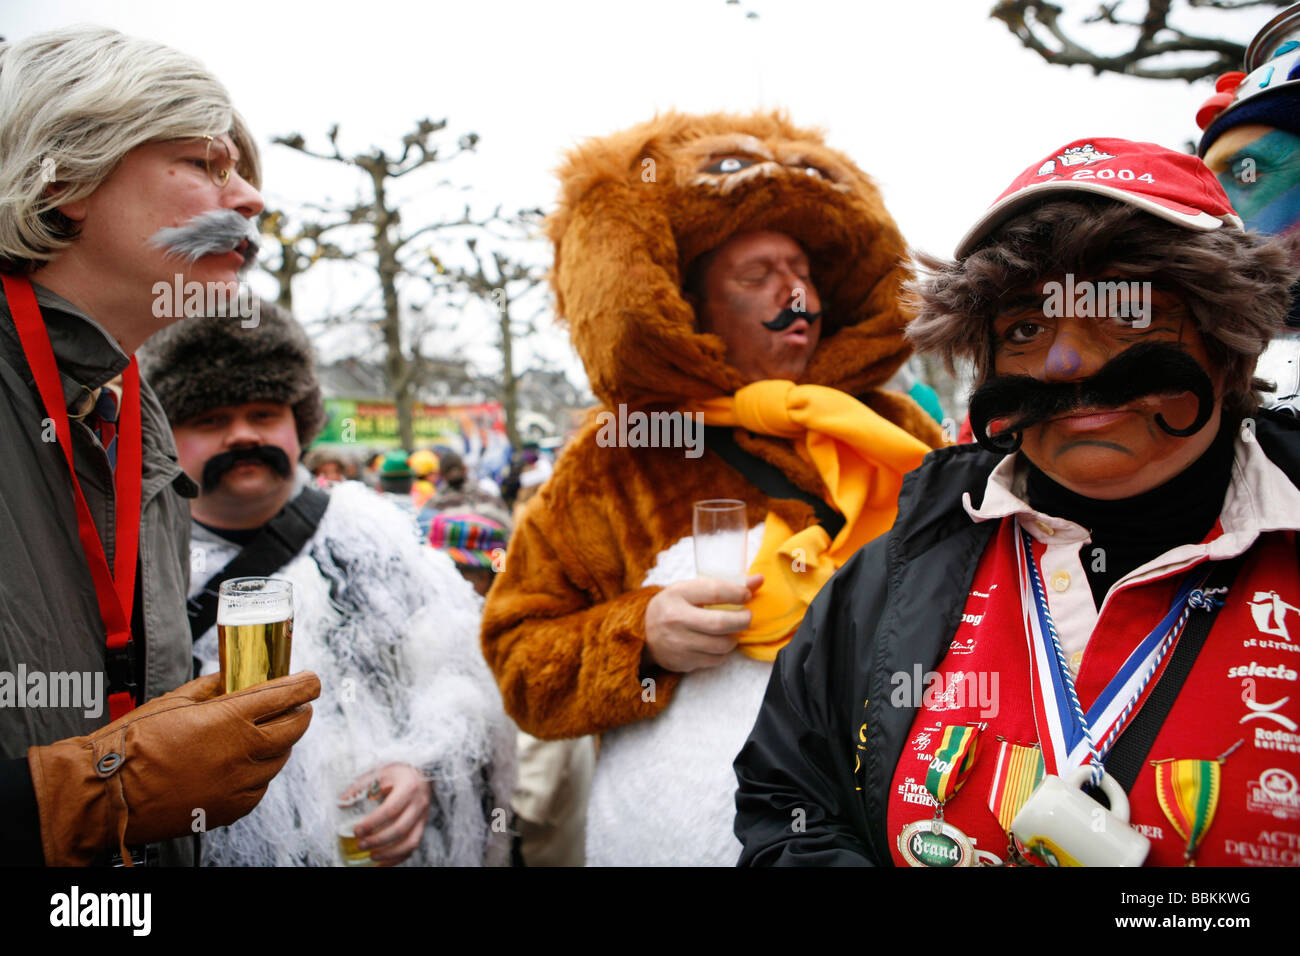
[736,139,1300,866]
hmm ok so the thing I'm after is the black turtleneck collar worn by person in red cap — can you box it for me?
[1026,416,1239,607]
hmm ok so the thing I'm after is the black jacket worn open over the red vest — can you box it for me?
[735,412,1300,866]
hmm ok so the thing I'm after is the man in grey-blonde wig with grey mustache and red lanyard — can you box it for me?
[0,29,320,865]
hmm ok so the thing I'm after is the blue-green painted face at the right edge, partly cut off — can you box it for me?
[1205,125,1300,235]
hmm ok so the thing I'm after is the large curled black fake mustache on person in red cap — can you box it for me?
[970,342,1214,455]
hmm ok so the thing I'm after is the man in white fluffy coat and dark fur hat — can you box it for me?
[142,304,514,866]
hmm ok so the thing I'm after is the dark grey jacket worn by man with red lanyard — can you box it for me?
[0,285,198,864]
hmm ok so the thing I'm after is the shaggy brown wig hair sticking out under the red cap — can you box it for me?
[906,196,1297,414]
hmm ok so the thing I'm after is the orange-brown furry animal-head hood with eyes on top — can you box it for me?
[547,113,913,416]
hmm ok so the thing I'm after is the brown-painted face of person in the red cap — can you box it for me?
[987,286,1222,499]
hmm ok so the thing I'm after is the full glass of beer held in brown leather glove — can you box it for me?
[217,578,294,693]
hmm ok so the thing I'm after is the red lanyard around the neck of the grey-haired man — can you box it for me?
[0,276,143,721]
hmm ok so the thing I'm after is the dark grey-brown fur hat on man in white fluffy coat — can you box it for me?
[138,300,325,449]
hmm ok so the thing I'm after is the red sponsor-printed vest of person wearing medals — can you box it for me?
[888,518,1300,866]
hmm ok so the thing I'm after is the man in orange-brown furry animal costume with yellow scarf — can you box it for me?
[482,113,943,865]
